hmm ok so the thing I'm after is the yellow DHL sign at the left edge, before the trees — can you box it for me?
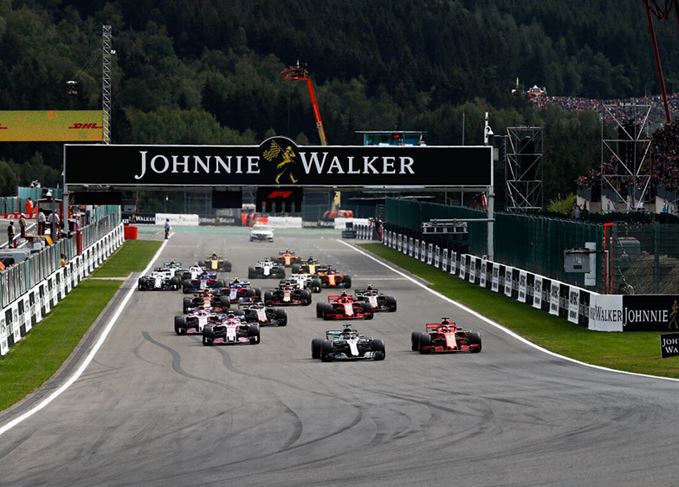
[0,110,104,142]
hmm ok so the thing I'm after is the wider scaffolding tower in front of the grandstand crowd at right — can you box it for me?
[601,103,652,213]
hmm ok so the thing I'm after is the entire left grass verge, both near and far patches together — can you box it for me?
[0,240,162,411]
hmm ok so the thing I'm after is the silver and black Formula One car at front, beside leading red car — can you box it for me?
[311,324,386,362]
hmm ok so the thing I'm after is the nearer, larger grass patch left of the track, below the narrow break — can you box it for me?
[0,280,121,411]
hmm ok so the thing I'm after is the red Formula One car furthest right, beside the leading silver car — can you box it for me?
[410,318,481,353]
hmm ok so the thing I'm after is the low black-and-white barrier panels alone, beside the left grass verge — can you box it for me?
[0,224,125,355]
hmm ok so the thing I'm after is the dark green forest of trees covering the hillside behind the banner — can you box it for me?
[0,0,679,204]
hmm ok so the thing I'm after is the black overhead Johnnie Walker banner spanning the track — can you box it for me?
[64,137,492,188]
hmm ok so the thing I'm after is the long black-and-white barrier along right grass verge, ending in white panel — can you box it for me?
[382,230,612,331]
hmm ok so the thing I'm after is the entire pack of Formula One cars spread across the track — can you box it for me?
[138,249,481,362]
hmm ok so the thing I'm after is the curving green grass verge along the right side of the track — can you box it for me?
[359,244,679,377]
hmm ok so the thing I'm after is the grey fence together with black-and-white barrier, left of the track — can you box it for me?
[0,215,124,355]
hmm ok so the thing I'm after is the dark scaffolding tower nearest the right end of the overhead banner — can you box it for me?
[505,127,544,211]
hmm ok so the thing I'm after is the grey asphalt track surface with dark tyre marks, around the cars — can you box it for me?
[0,230,679,487]
